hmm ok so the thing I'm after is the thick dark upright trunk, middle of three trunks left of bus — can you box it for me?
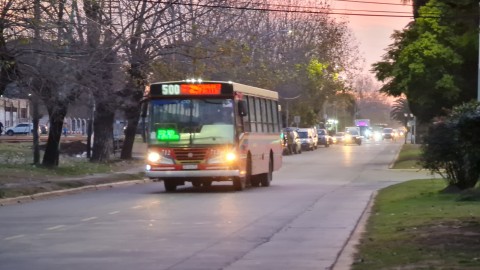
[90,100,115,162]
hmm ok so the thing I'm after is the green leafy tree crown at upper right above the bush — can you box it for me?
[373,0,478,122]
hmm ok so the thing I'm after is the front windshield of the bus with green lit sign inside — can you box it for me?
[148,98,234,146]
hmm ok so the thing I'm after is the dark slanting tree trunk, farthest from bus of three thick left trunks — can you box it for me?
[42,103,67,168]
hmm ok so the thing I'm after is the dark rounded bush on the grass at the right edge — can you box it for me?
[421,102,480,190]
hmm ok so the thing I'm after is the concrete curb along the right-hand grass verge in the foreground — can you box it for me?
[331,192,377,270]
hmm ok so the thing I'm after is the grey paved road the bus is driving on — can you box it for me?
[0,142,434,270]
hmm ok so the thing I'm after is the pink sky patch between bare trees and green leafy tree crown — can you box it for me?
[330,0,413,72]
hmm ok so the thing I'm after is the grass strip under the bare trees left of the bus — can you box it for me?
[0,142,142,198]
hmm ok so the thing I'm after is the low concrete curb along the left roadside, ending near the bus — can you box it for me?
[0,178,153,206]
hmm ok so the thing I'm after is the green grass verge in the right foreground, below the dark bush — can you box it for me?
[352,179,480,270]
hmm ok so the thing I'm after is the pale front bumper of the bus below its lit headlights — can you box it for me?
[145,170,241,178]
